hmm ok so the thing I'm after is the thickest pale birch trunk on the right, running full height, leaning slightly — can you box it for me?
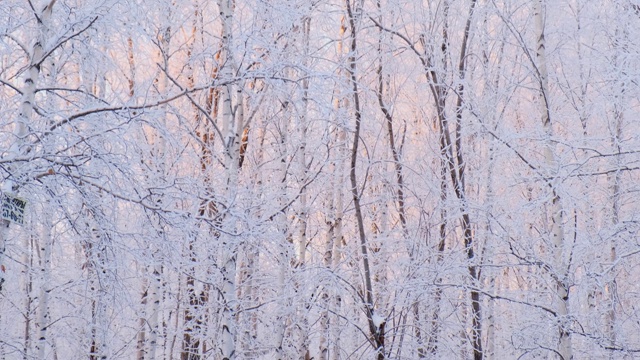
[535,0,573,360]
